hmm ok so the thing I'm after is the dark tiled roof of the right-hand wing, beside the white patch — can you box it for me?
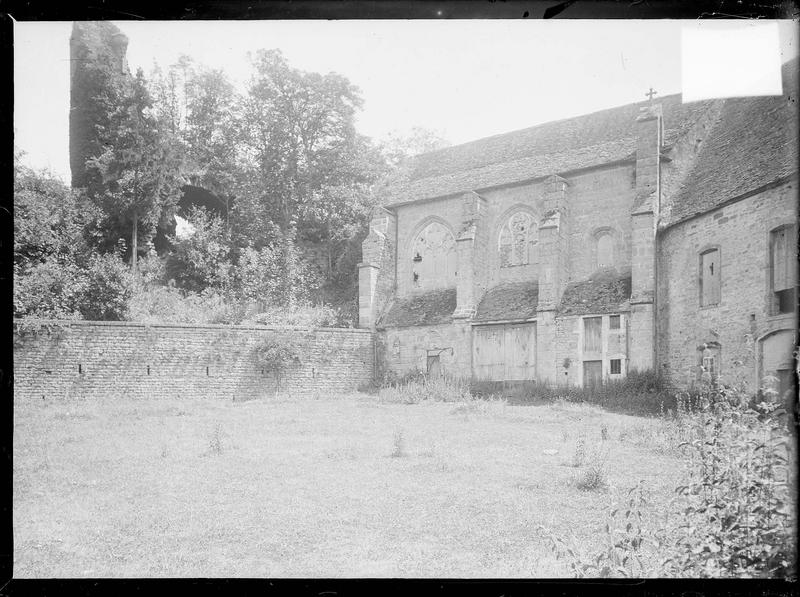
[667,59,798,224]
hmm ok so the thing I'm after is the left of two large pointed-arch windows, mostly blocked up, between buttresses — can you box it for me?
[411,222,456,288]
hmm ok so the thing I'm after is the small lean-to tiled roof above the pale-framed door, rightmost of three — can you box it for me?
[558,269,631,315]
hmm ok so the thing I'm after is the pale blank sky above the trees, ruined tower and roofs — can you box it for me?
[14,20,798,181]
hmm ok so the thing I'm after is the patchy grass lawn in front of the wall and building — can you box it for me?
[14,394,682,578]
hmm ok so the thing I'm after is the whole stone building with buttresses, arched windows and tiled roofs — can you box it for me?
[359,60,798,396]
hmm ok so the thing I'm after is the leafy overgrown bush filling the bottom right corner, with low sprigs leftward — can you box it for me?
[542,385,797,578]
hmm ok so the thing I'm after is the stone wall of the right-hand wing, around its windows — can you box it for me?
[656,181,797,388]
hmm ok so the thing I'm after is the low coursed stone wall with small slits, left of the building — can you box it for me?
[14,321,374,400]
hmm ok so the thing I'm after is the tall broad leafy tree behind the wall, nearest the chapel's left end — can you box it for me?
[231,50,368,241]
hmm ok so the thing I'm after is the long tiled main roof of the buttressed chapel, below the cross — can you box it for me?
[383,94,712,204]
